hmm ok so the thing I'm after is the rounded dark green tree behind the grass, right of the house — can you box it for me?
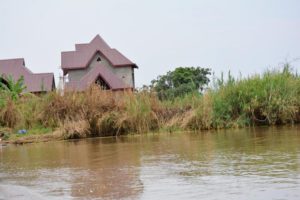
[151,67,211,100]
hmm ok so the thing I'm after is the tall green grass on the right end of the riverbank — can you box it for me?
[212,69,300,127]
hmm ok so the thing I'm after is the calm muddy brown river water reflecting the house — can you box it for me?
[0,126,300,200]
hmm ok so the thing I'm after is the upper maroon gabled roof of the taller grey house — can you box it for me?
[61,35,137,73]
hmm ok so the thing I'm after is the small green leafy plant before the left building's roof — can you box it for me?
[0,76,26,100]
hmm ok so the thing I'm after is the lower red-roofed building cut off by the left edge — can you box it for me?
[0,58,55,93]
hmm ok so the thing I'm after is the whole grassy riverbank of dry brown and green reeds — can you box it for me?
[0,68,300,144]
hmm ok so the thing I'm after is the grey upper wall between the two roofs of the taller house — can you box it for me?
[68,53,134,87]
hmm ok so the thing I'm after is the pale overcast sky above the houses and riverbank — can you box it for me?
[0,0,300,87]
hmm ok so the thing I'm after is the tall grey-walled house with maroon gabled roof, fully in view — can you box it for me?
[61,35,137,91]
